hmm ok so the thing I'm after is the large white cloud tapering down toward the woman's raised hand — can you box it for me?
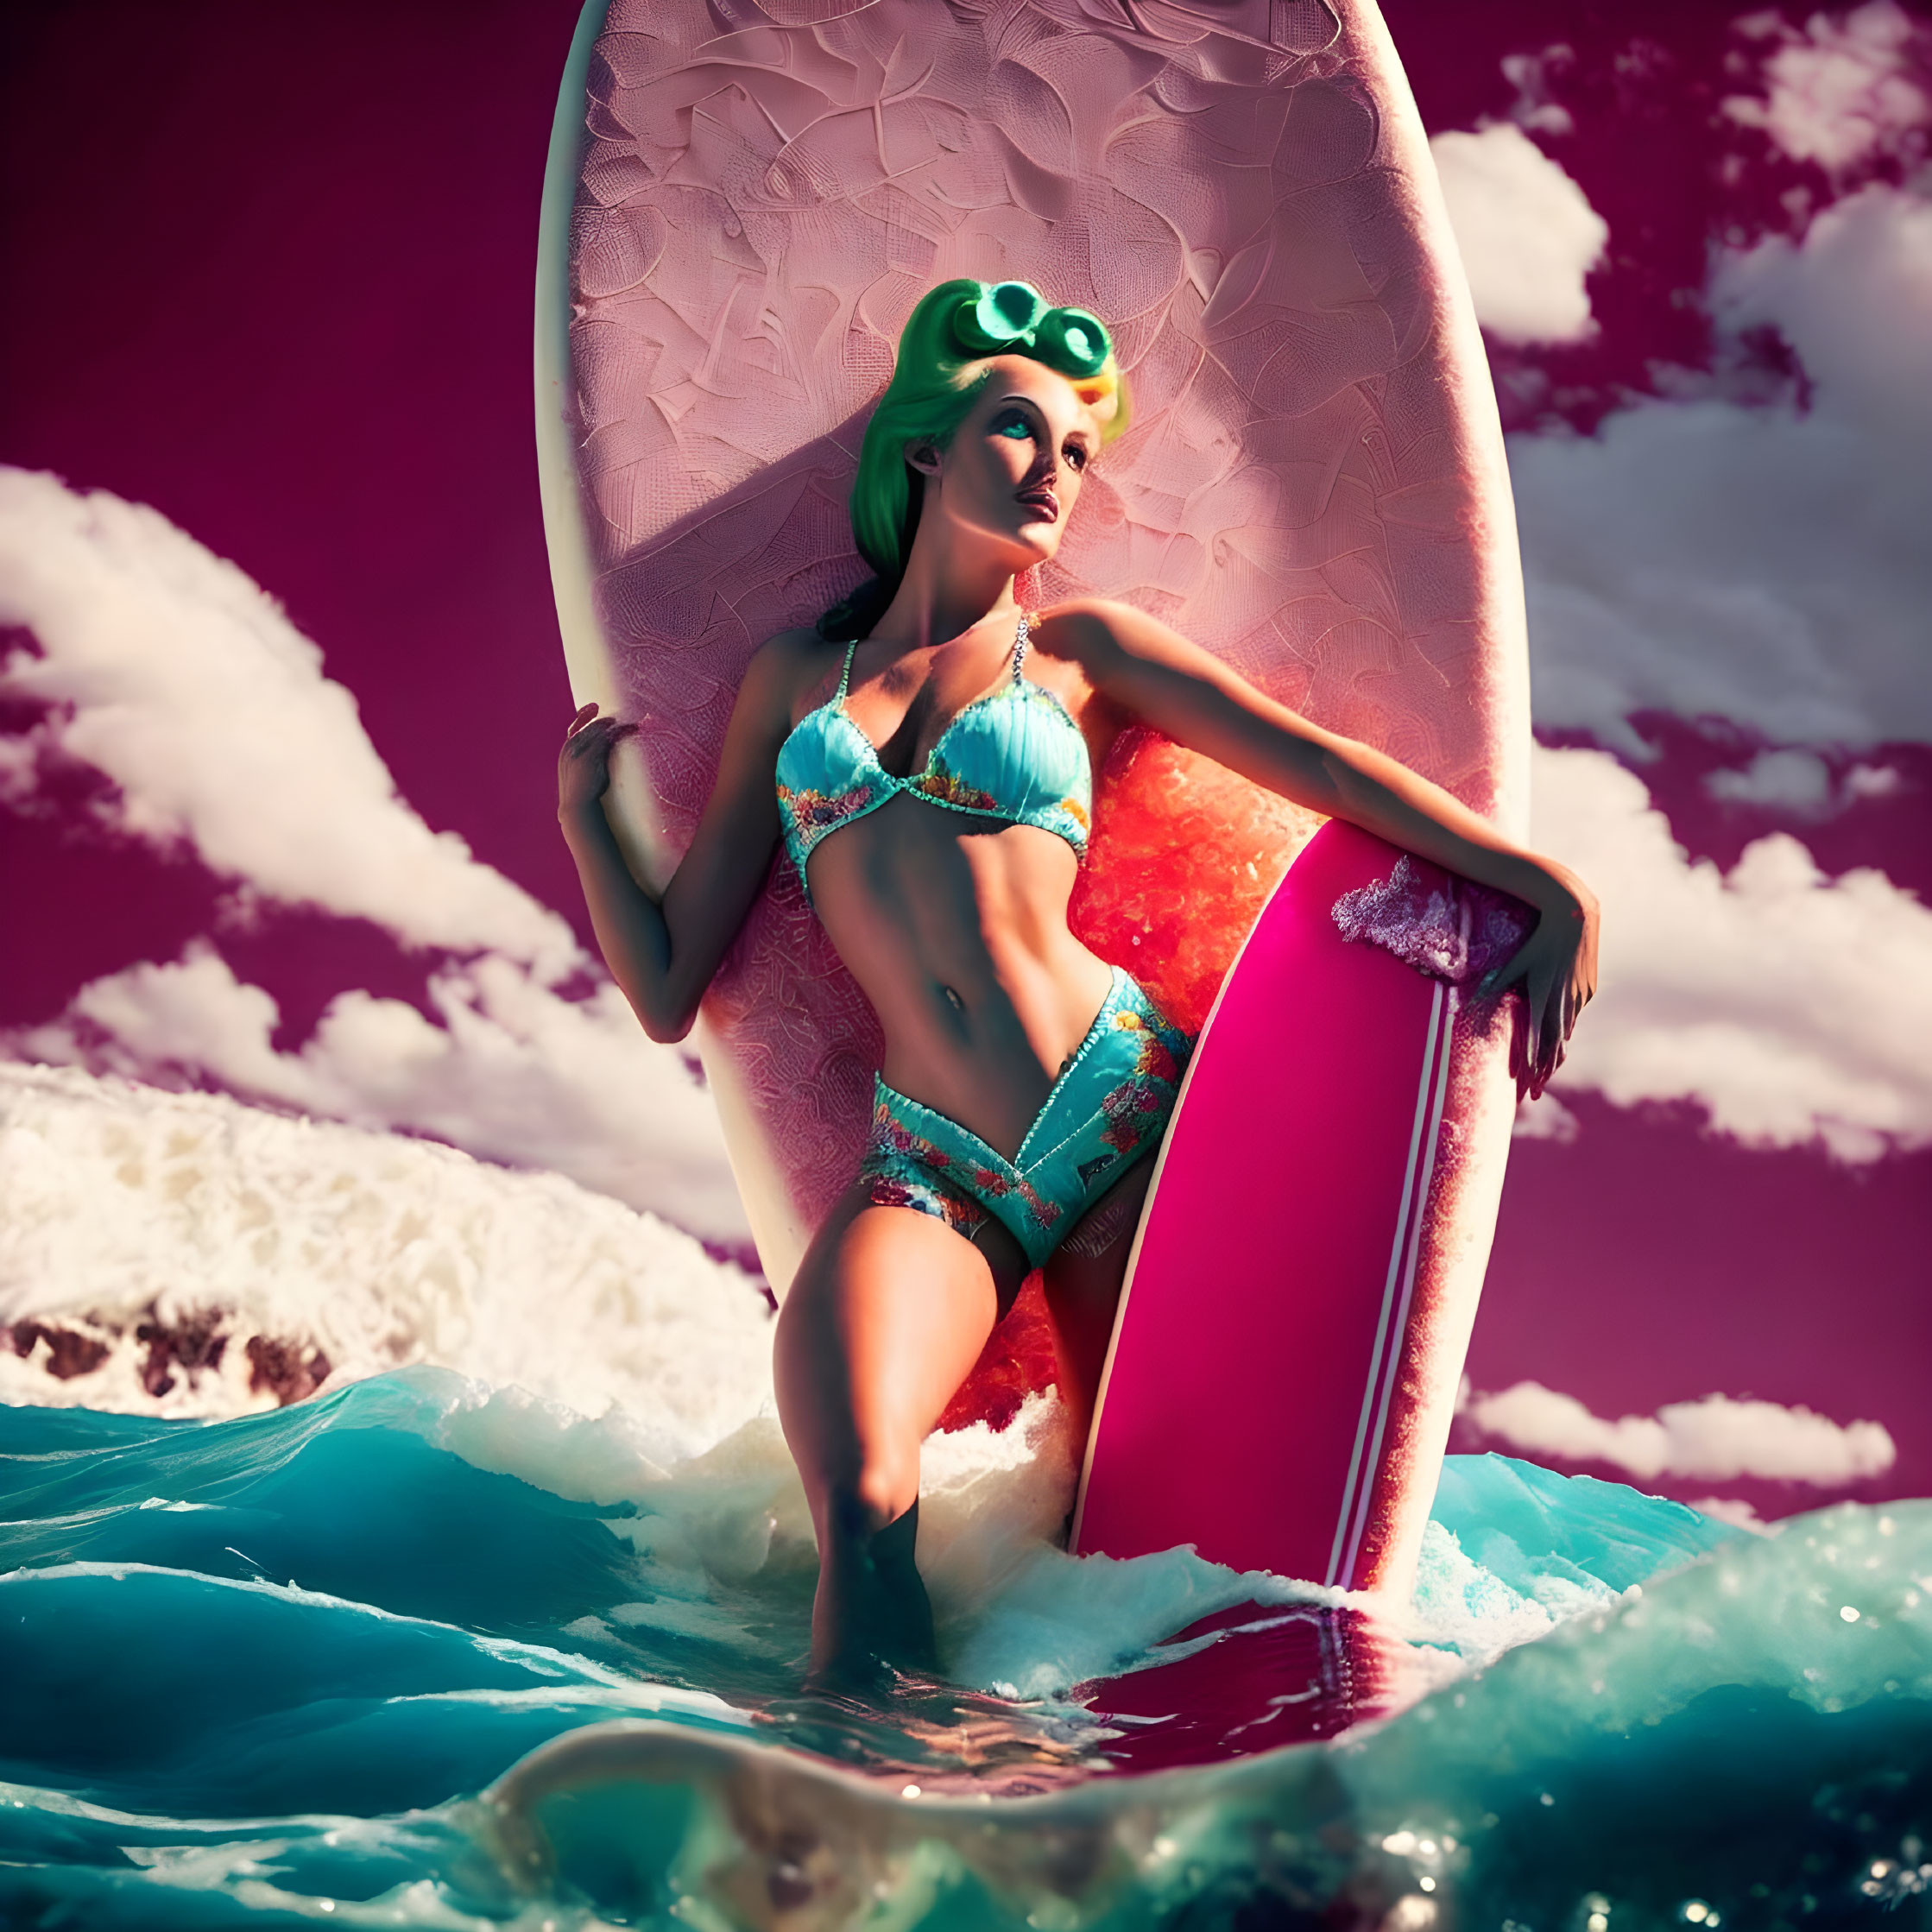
[0,468,576,972]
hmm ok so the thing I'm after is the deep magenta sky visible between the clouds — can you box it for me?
[0,0,1932,1515]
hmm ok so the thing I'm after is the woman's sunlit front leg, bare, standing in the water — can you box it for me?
[773,1188,1026,1681]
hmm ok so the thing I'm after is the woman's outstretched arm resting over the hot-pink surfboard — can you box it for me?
[1044,599,1598,1095]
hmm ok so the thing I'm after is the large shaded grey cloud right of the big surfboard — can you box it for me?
[1509,187,1932,757]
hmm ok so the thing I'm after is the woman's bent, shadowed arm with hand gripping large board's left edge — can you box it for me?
[557,634,804,1041]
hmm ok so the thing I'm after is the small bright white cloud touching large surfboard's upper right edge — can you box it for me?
[1430,122,1609,342]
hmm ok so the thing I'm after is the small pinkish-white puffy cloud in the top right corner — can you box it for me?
[1723,0,1932,174]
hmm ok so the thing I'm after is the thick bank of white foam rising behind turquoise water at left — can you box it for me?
[0,1064,771,1462]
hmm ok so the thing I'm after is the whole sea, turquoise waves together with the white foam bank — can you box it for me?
[0,1066,1932,1932]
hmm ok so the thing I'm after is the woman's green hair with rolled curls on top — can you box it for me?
[819,276,1127,640]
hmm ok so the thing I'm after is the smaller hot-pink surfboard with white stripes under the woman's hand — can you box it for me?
[1074,825,1501,1590]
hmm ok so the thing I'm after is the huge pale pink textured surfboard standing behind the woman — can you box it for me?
[537,0,1528,1329]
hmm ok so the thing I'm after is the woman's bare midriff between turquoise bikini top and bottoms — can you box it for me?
[810,796,1111,1158]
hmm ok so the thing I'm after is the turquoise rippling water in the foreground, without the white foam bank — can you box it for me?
[0,1370,1932,1932]
